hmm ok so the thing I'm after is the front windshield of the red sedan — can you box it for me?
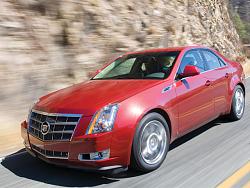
[92,51,180,80]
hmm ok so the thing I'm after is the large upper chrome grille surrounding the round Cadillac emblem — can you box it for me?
[28,110,81,141]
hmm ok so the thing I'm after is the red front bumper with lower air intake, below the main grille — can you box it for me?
[21,122,127,171]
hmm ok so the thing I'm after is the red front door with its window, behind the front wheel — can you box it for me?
[175,50,214,135]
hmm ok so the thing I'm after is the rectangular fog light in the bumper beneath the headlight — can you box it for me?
[78,149,110,161]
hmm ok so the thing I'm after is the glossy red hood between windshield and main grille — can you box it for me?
[34,80,161,116]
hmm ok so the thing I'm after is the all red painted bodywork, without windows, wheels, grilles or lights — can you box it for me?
[21,46,244,169]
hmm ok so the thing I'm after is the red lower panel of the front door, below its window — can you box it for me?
[176,73,215,135]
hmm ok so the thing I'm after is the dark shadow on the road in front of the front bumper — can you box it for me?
[1,151,119,187]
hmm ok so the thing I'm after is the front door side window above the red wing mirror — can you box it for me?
[178,50,206,74]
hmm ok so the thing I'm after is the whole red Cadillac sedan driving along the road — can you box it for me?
[21,46,245,172]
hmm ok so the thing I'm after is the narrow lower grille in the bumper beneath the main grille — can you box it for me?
[31,144,69,159]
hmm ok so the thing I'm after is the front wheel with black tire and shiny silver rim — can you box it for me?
[131,113,170,172]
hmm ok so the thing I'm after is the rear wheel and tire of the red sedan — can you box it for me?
[229,85,245,121]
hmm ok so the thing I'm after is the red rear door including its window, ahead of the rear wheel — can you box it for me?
[202,49,231,116]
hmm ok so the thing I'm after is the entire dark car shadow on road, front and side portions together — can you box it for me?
[1,118,230,187]
